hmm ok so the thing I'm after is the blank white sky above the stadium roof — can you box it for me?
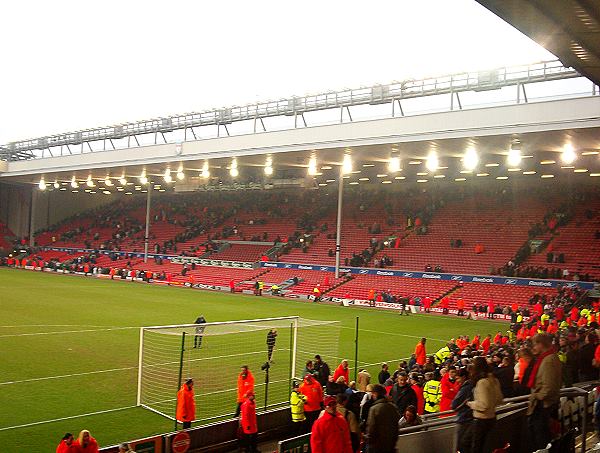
[0,0,554,144]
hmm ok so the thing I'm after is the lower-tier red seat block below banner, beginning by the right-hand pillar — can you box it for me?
[327,275,456,300]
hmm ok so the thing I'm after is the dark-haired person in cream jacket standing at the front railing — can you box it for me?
[467,357,503,453]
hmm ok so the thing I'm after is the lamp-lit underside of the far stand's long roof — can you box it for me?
[6,128,600,193]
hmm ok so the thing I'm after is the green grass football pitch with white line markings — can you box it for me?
[0,268,507,453]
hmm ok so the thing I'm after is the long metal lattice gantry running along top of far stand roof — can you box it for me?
[0,60,592,161]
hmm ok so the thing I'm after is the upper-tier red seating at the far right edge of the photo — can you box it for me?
[523,200,600,280]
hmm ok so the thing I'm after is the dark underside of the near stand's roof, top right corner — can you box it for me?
[477,0,600,84]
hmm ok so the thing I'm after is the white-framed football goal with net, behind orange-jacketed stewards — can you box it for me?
[137,316,340,422]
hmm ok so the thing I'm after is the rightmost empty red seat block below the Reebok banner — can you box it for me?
[450,283,557,310]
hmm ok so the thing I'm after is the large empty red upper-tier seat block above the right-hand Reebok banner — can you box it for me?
[379,196,548,275]
